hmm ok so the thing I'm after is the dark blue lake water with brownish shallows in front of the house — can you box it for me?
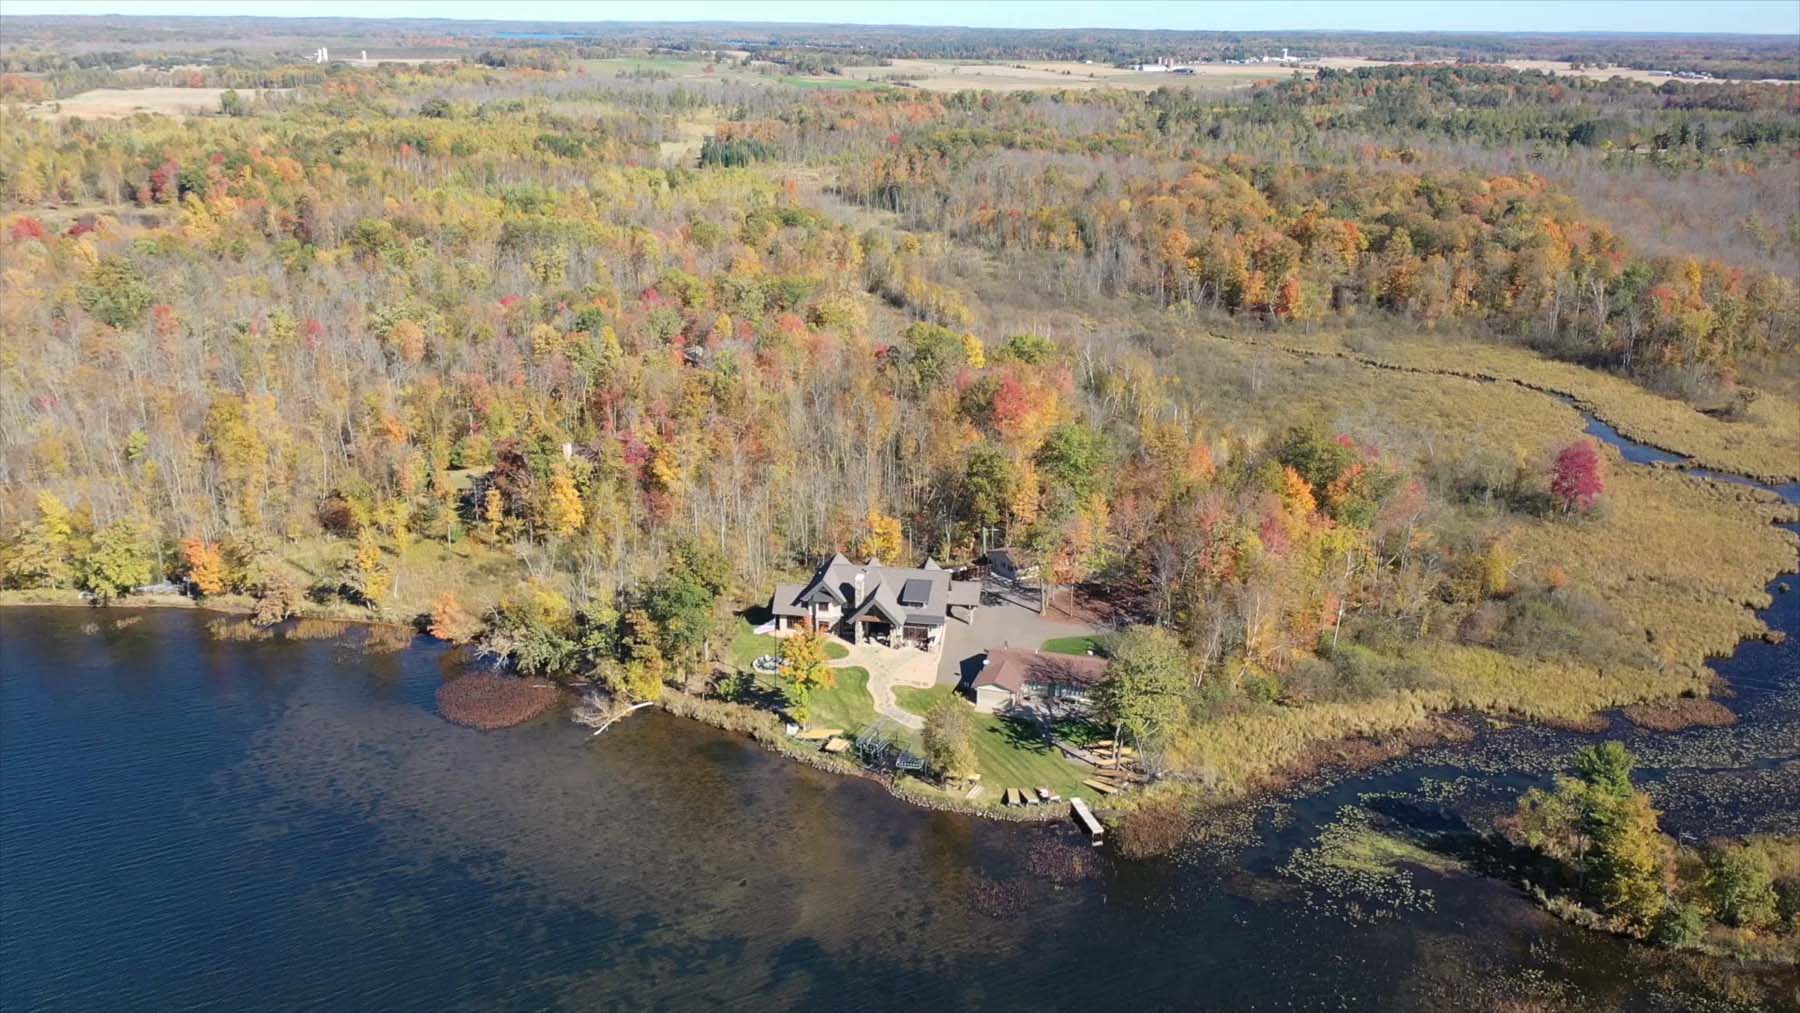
[0,421,1800,1009]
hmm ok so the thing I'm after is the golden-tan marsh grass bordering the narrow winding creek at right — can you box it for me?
[1123,329,1800,799]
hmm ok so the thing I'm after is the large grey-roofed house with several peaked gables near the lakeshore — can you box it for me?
[769,554,981,651]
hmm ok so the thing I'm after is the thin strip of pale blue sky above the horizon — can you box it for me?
[0,0,1800,36]
